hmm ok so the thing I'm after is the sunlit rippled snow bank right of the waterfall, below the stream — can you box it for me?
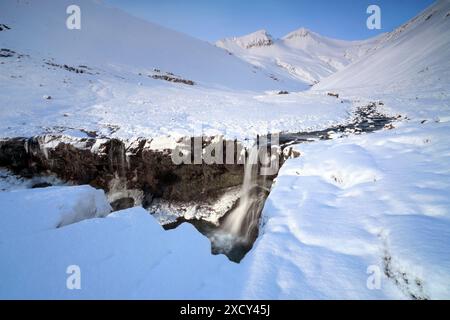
[248,119,450,299]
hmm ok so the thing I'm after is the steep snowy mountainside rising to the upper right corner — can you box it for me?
[314,0,450,95]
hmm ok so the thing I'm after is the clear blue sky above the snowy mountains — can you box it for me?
[105,0,434,41]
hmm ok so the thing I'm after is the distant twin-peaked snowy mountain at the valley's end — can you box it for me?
[216,28,383,85]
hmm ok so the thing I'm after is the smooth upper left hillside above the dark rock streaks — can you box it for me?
[0,0,279,89]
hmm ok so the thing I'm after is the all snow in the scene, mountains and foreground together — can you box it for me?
[0,0,450,299]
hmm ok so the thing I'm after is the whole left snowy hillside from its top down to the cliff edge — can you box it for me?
[0,0,351,140]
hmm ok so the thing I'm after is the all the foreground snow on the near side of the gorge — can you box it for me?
[0,122,450,299]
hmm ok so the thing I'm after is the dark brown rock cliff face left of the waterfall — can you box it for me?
[0,135,243,201]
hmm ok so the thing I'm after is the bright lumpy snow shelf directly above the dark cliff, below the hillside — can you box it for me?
[0,50,352,141]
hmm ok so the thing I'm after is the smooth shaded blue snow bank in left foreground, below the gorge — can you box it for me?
[0,204,229,299]
